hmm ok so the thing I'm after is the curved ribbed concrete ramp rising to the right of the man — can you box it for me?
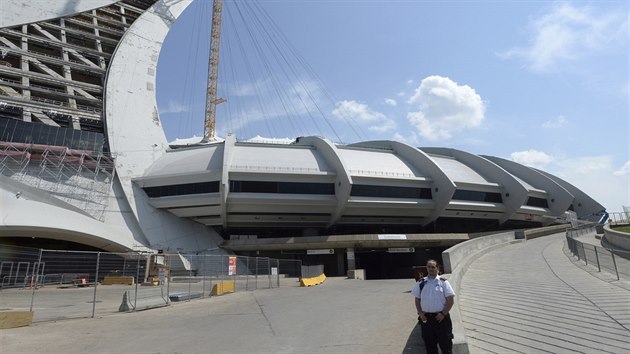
[459,234,630,354]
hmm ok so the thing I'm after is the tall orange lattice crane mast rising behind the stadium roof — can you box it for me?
[202,0,225,142]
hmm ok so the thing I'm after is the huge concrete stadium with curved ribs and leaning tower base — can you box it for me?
[0,0,605,272]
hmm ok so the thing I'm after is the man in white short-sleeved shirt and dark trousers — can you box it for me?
[411,259,455,354]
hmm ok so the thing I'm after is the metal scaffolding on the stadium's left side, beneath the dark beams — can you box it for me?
[0,142,115,221]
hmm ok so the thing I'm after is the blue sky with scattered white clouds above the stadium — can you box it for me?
[157,0,630,211]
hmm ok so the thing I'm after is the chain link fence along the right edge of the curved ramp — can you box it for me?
[566,226,630,280]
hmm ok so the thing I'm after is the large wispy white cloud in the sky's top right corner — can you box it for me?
[498,3,628,72]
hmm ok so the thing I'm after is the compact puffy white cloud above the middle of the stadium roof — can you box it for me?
[407,76,485,141]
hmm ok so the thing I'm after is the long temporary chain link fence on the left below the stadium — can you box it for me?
[0,245,302,322]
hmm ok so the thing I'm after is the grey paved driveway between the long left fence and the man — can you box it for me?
[0,278,424,354]
